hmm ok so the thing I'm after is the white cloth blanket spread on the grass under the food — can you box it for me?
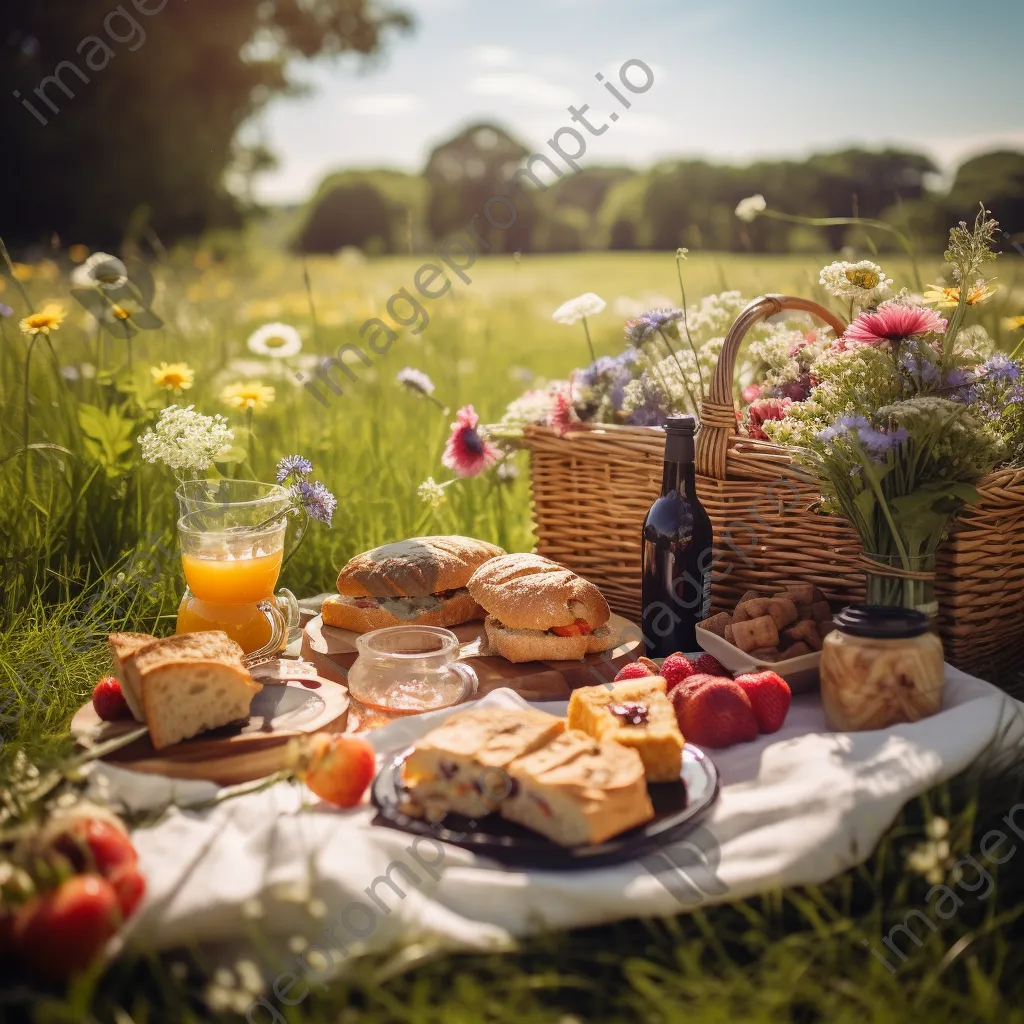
[103,668,1024,999]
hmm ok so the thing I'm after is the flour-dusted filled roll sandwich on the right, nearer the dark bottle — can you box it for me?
[469,554,618,662]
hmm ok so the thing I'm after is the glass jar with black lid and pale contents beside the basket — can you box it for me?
[821,604,945,732]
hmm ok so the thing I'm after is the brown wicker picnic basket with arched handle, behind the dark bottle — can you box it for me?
[526,295,1024,672]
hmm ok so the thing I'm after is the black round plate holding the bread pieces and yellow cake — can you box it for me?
[371,743,719,869]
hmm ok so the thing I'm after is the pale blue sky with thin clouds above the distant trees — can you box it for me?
[253,0,1024,201]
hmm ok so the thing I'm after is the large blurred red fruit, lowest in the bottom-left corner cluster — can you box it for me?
[14,874,121,981]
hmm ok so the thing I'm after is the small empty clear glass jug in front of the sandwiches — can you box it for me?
[348,626,477,717]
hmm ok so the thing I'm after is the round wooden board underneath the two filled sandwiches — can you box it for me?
[302,614,643,700]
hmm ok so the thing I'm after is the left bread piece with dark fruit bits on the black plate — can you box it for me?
[401,708,565,818]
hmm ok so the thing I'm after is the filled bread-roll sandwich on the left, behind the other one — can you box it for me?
[322,537,505,633]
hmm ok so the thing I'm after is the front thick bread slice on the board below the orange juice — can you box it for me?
[141,658,263,751]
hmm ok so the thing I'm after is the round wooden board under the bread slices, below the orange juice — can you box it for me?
[71,659,349,785]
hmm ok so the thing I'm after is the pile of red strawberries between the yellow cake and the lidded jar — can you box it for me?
[615,653,792,749]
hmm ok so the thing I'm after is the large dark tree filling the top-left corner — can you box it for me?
[0,0,411,246]
